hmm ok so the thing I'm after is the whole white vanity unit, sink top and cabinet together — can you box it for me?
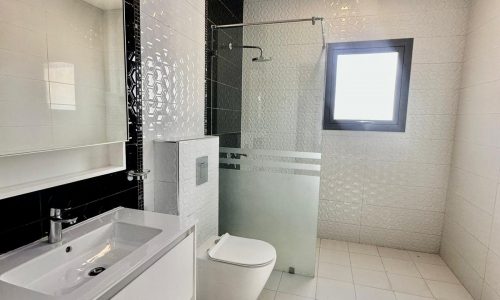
[0,207,196,300]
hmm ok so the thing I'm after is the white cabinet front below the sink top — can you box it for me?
[112,233,196,300]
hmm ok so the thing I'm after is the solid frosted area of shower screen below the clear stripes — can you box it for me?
[219,169,319,276]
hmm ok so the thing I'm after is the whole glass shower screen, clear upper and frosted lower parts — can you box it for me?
[207,17,324,276]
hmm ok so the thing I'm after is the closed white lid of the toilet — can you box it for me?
[208,233,276,267]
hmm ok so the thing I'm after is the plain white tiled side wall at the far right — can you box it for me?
[441,0,500,299]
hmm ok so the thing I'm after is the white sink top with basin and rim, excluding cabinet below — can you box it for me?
[0,208,194,300]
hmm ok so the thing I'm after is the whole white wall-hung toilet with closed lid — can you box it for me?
[196,233,276,300]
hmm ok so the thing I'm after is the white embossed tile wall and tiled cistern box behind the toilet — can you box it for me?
[141,0,209,243]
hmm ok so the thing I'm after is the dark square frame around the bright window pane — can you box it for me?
[323,38,413,132]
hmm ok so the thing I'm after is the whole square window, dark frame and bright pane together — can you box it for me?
[323,39,413,131]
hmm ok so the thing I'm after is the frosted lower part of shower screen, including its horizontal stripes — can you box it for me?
[219,148,321,276]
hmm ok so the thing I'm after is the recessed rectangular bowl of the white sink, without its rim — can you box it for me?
[0,222,162,296]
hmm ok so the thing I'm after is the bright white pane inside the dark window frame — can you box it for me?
[333,52,398,121]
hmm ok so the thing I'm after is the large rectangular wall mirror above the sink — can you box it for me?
[0,0,128,156]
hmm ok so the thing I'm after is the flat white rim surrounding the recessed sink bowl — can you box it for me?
[0,207,194,300]
